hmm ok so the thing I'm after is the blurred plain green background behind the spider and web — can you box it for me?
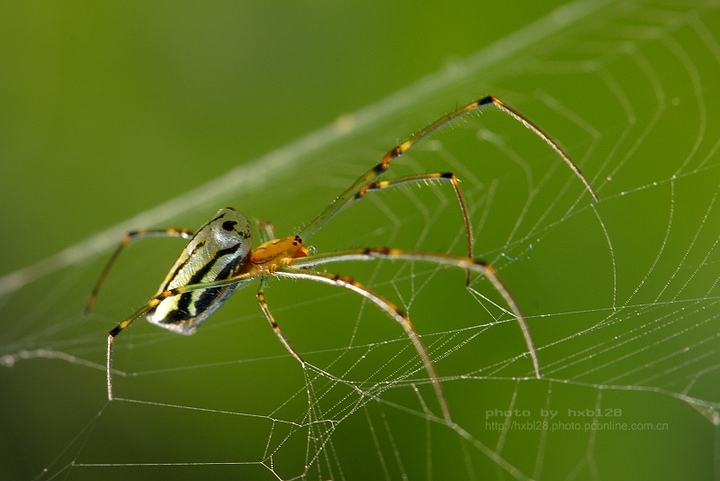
[0,1,720,479]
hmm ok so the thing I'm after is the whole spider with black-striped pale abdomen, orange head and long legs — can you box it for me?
[86,96,597,423]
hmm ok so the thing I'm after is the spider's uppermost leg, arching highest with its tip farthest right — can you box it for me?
[299,96,598,240]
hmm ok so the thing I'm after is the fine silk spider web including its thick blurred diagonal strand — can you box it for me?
[0,1,720,479]
